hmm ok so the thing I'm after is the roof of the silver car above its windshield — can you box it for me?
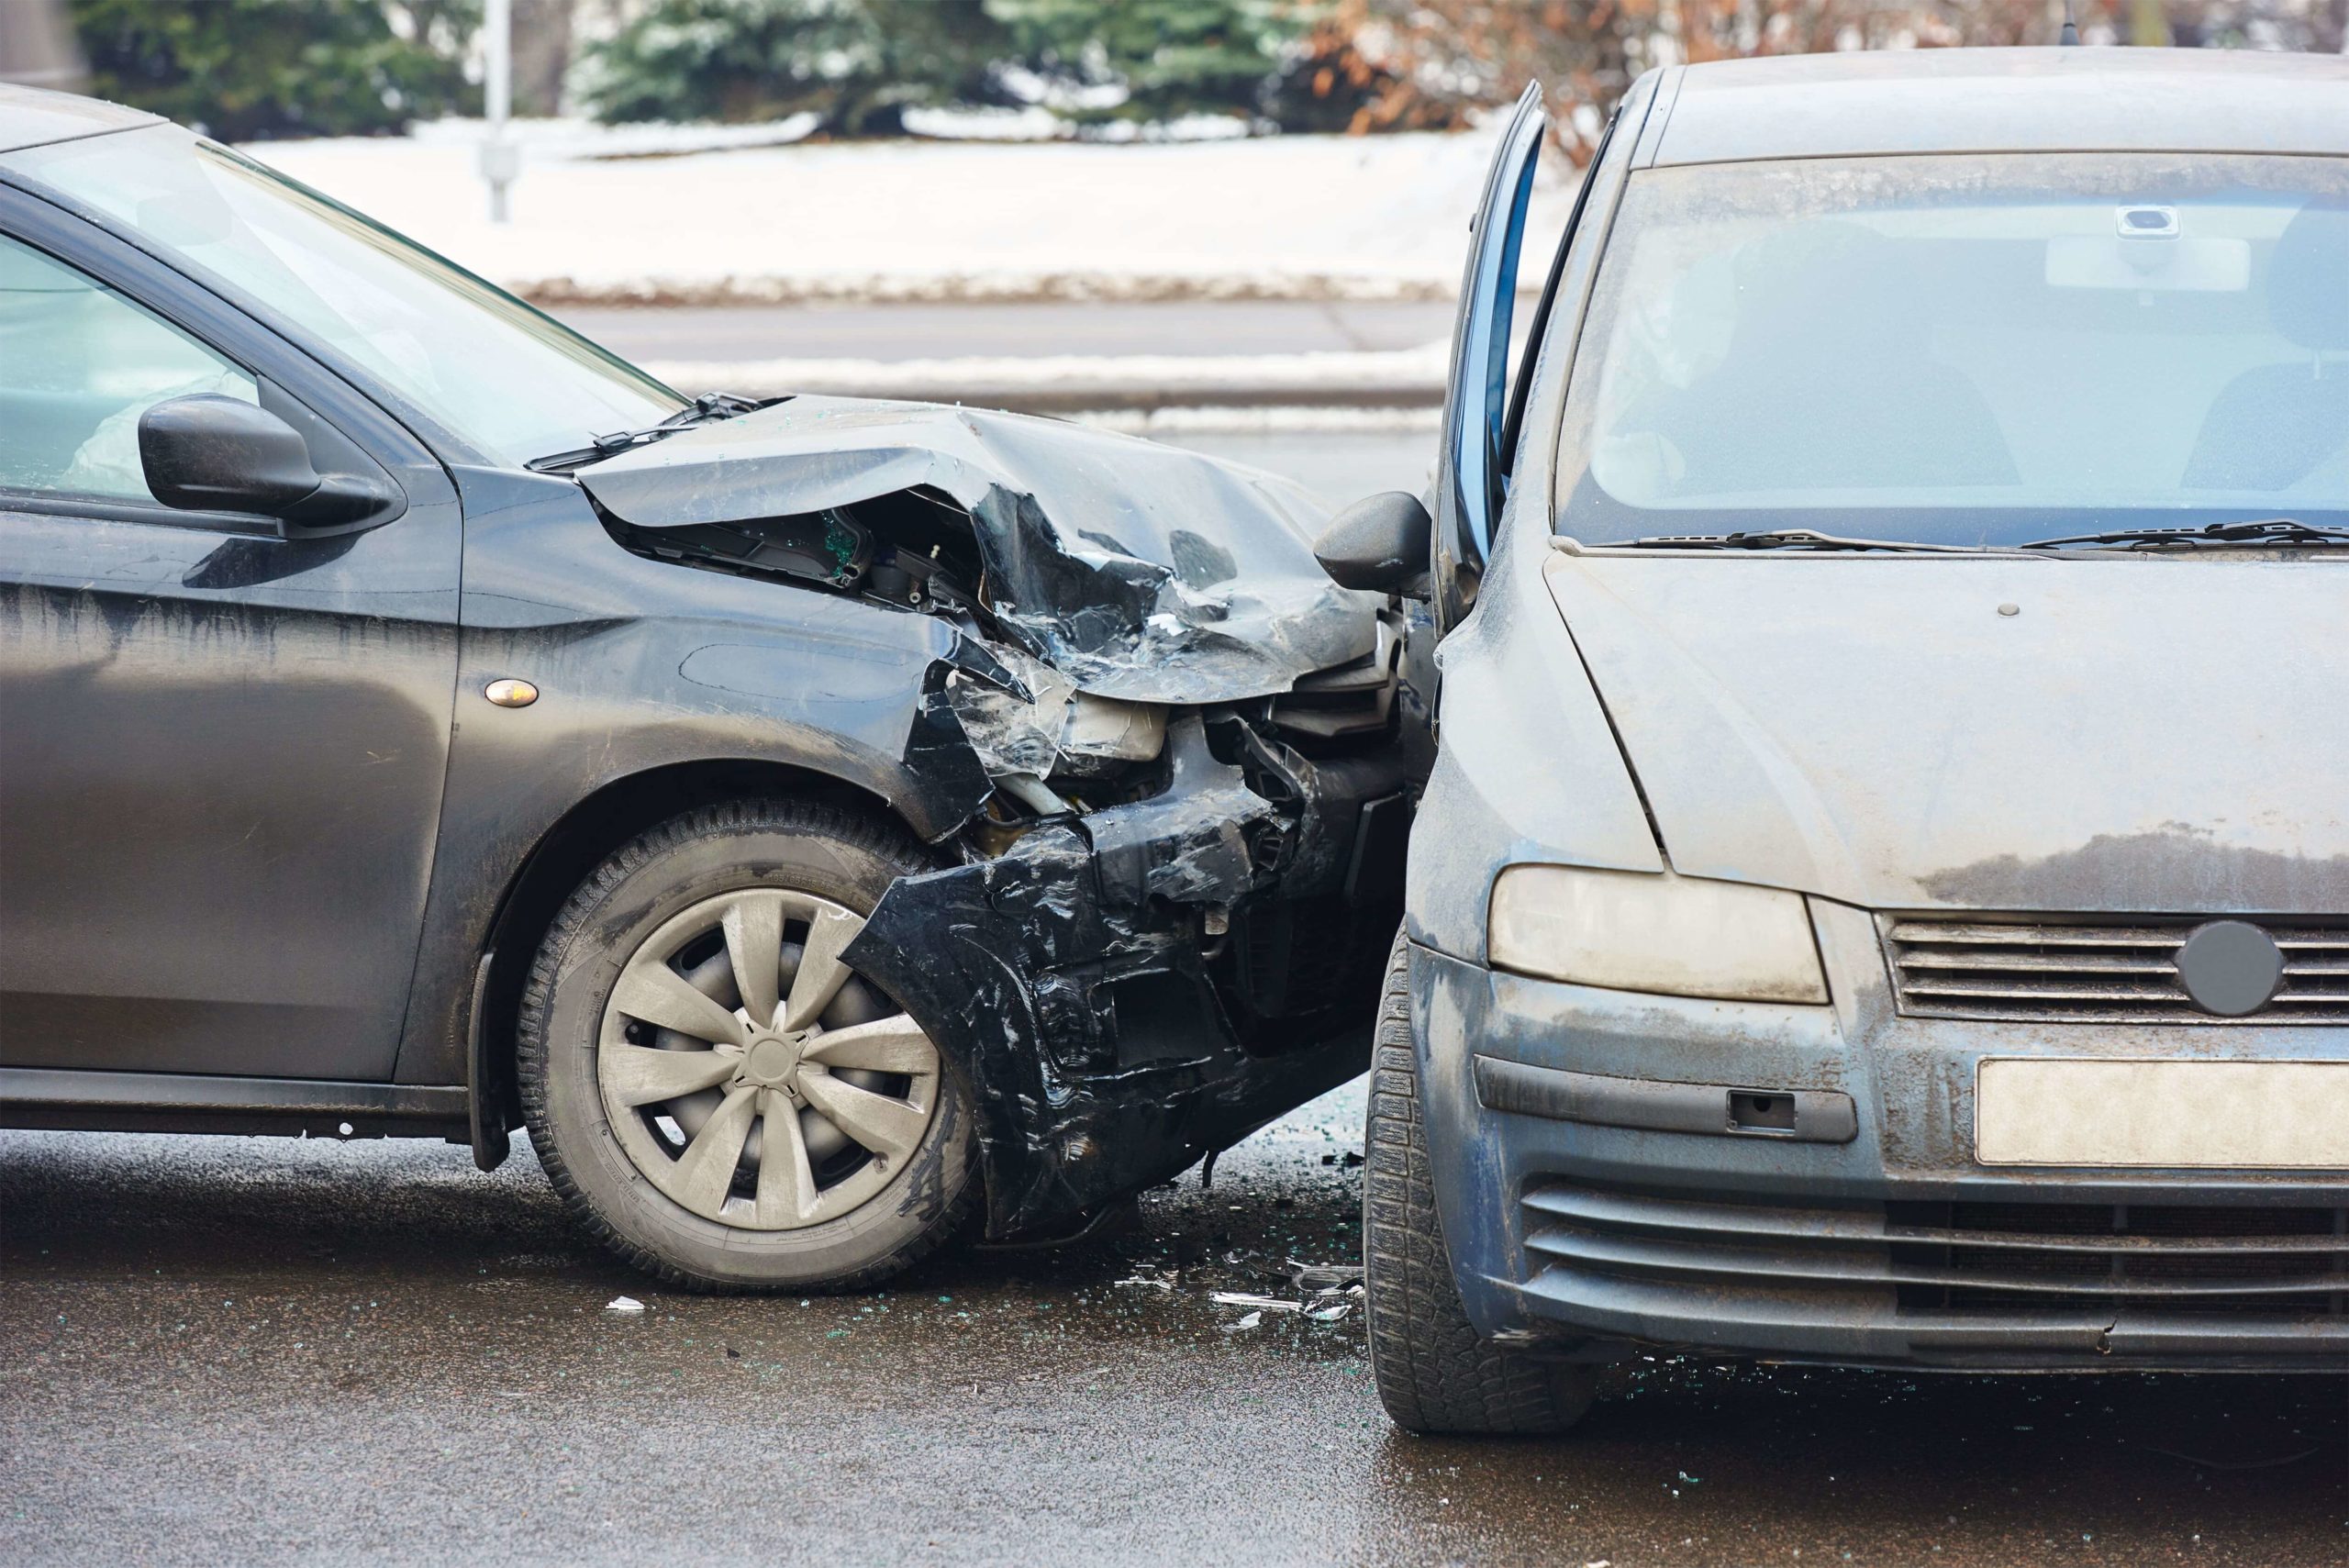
[1640,47,2349,164]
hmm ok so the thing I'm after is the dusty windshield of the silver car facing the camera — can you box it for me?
[1560,152,2349,545]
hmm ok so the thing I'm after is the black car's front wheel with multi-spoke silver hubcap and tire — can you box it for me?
[517,800,982,1291]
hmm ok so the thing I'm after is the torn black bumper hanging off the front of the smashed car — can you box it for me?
[848,714,1409,1240]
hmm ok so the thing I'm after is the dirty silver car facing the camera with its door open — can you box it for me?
[1322,50,2349,1432]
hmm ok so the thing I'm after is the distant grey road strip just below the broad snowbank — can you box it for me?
[554,300,1452,361]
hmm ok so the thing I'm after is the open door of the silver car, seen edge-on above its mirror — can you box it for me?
[1433,83,1551,634]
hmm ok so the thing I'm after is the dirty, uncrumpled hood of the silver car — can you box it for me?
[1545,554,2349,916]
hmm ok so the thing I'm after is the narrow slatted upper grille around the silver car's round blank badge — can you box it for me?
[1884,916,2349,1026]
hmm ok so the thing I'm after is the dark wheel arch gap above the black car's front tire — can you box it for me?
[467,758,918,1172]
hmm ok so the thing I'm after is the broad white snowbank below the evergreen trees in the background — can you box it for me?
[247,122,1572,303]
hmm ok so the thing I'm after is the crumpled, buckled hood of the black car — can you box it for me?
[578,396,1379,702]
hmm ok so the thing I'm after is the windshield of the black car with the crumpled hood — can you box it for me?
[0,127,686,465]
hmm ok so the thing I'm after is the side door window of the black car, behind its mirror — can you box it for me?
[0,237,259,502]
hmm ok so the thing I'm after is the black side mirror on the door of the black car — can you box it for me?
[139,392,397,528]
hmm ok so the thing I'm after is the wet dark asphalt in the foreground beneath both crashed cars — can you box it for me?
[0,1087,2349,1568]
